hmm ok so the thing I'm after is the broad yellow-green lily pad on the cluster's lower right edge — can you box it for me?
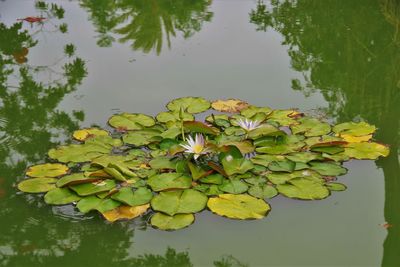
[276,178,330,200]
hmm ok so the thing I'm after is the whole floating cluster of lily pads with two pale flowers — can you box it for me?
[18,97,389,230]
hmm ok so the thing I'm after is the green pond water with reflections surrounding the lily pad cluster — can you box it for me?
[0,0,400,267]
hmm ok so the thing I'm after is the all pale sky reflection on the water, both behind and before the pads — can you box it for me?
[0,1,385,266]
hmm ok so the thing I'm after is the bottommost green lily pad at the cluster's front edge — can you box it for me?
[150,212,194,230]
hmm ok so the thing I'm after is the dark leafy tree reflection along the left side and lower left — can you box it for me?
[0,2,244,267]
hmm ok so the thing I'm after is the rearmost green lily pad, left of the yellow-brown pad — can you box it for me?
[167,97,211,114]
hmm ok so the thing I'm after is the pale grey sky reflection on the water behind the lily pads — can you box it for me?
[1,1,325,129]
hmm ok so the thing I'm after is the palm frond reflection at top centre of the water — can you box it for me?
[81,0,212,54]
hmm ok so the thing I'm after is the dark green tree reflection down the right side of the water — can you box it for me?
[250,0,400,266]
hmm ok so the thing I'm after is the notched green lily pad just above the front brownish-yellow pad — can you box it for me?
[111,187,153,206]
